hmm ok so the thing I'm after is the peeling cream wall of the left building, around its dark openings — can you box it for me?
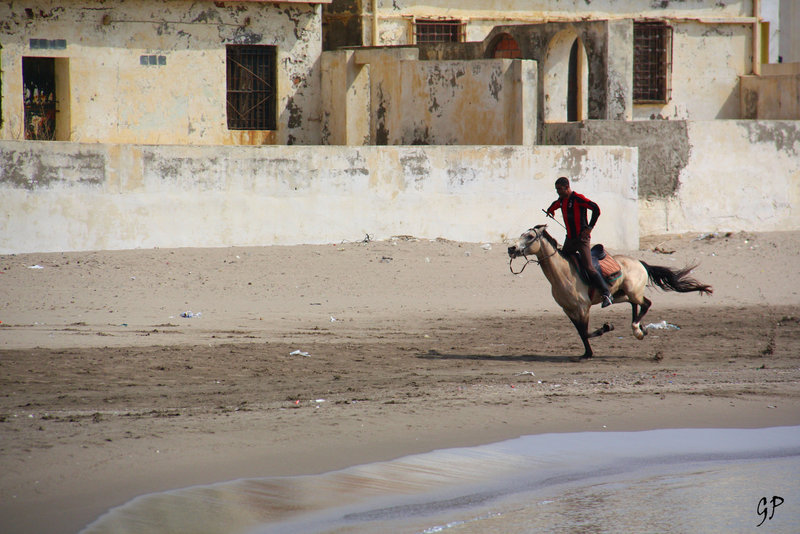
[0,0,322,145]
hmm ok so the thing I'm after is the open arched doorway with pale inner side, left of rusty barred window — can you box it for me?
[543,29,589,122]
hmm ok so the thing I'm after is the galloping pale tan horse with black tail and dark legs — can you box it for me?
[508,224,714,358]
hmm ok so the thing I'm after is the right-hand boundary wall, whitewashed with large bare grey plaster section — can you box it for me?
[546,121,800,235]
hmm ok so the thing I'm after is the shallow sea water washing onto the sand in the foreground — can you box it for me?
[83,427,800,534]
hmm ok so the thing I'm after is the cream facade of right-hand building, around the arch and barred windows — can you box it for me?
[362,0,755,121]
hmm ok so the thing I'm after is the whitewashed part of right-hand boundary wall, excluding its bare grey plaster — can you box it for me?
[639,121,800,234]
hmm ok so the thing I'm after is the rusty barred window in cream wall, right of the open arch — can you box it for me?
[633,22,672,104]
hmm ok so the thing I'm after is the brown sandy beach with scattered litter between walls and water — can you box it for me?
[0,232,800,533]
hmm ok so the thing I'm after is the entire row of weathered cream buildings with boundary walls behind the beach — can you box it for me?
[0,0,800,252]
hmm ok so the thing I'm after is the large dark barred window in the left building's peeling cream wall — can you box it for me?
[227,45,277,130]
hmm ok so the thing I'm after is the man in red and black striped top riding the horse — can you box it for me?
[547,176,614,308]
